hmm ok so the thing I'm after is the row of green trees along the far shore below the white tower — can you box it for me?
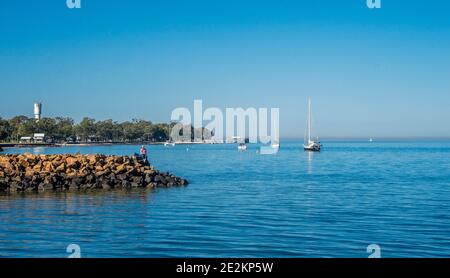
[0,116,211,142]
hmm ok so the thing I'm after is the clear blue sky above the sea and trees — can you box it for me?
[0,0,450,137]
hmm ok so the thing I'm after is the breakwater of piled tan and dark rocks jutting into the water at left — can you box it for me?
[0,154,188,193]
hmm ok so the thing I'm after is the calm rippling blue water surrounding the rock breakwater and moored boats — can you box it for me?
[0,142,450,257]
